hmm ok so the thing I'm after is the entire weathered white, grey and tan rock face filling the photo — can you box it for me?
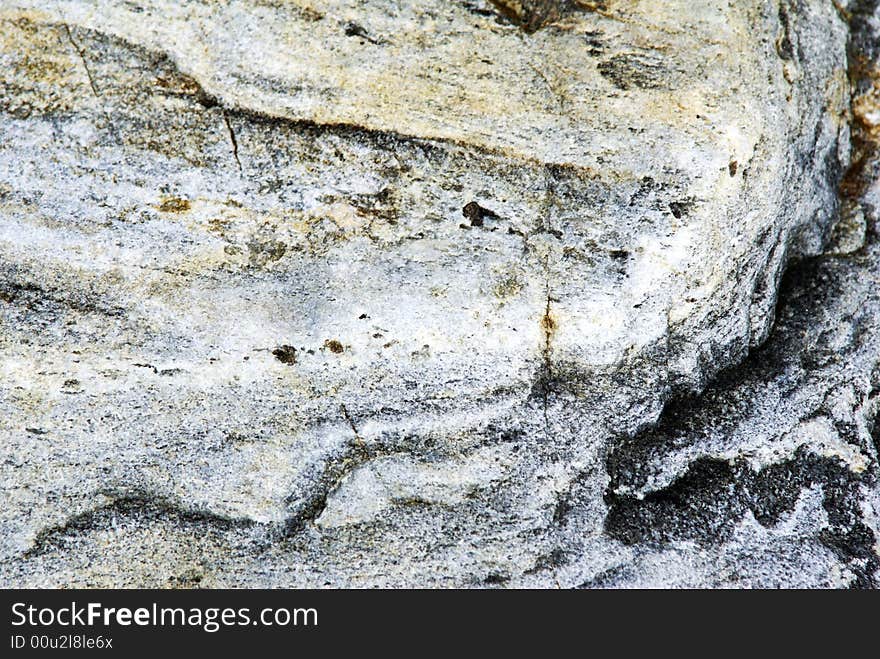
[0,0,880,586]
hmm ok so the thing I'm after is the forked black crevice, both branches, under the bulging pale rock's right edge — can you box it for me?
[606,240,878,585]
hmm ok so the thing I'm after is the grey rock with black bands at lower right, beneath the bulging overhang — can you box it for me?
[596,240,880,587]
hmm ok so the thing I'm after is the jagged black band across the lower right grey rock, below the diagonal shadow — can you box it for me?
[605,449,880,587]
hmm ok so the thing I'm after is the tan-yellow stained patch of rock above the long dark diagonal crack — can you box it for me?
[0,0,768,175]
